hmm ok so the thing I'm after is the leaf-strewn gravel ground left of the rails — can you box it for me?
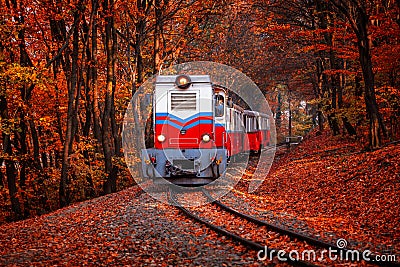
[0,187,272,266]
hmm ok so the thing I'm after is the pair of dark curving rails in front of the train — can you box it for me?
[169,189,400,266]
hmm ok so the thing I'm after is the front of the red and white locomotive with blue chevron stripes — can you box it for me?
[142,75,226,185]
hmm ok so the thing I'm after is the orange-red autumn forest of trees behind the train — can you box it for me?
[0,0,400,223]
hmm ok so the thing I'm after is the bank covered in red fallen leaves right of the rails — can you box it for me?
[238,131,400,255]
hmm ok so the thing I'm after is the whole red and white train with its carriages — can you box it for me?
[141,74,270,185]
